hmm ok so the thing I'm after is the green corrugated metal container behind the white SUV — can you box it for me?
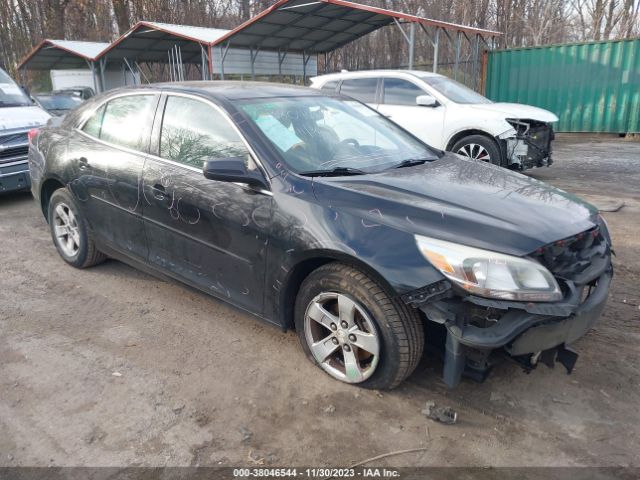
[485,39,640,133]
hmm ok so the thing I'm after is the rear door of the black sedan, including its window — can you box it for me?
[68,93,160,260]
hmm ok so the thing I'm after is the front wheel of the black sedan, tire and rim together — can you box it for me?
[295,263,424,389]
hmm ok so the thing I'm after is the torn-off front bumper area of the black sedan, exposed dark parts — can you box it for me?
[403,226,613,388]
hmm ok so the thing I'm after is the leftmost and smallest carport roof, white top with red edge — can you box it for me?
[18,39,109,70]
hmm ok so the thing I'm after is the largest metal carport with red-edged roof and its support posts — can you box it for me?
[214,0,501,85]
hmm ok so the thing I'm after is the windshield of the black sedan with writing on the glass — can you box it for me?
[240,96,438,174]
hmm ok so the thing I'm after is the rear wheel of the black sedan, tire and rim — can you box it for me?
[48,188,107,268]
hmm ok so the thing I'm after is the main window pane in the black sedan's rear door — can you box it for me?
[99,95,155,151]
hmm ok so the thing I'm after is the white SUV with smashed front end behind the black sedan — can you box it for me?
[311,70,558,170]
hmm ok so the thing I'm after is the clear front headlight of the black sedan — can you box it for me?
[415,235,562,302]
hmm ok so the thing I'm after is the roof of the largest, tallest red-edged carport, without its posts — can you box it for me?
[214,0,501,53]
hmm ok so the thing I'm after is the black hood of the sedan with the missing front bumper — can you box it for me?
[314,154,598,255]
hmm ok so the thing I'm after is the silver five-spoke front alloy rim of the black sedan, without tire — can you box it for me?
[304,292,380,383]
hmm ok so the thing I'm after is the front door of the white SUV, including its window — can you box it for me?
[378,77,445,148]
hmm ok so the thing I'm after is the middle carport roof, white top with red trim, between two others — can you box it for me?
[100,21,229,63]
